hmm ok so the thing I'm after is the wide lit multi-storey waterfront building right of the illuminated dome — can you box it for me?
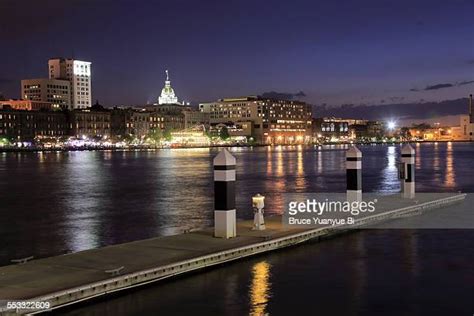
[199,96,312,144]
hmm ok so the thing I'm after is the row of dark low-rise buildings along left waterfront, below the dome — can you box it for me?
[0,101,171,141]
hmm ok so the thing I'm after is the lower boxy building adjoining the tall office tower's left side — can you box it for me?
[21,78,71,109]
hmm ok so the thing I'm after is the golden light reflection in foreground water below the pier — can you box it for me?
[249,261,271,315]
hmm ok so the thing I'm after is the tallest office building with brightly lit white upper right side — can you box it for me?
[48,58,92,109]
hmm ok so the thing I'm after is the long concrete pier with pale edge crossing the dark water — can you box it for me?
[0,193,465,315]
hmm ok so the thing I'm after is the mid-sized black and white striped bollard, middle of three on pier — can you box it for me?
[346,146,362,202]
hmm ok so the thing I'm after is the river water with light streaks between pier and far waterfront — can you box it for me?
[0,143,474,264]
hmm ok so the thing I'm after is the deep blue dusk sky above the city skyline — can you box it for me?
[0,0,474,106]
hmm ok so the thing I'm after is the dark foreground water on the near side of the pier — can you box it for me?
[60,230,474,316]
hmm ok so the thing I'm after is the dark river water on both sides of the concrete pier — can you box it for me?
[0,143,474,315]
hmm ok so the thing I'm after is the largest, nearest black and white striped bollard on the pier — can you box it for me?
[214,148,237,238]
